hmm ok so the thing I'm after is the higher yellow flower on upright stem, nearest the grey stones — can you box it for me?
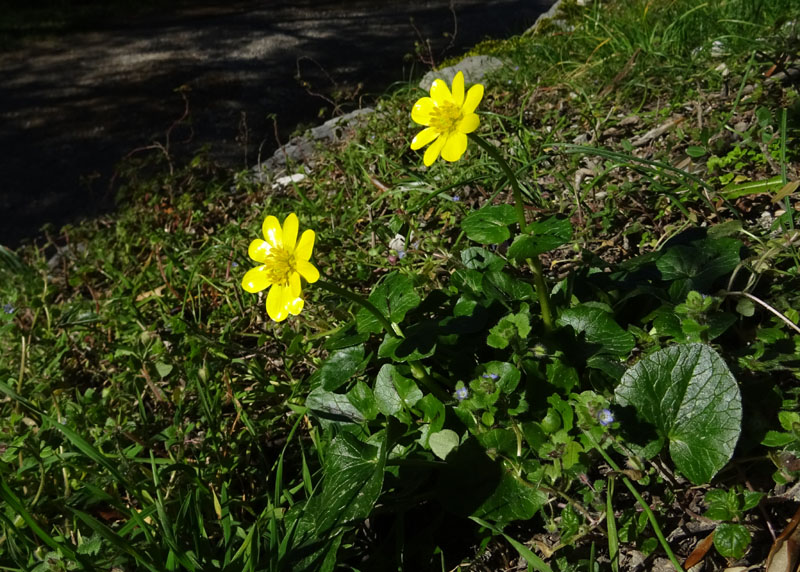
[411,72,483,167]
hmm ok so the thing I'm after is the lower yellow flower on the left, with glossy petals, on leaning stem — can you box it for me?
[242,213,319,322]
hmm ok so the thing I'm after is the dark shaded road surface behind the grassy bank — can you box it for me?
[0,0,553,247]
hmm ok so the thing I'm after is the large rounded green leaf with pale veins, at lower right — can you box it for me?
[616,344,742,484]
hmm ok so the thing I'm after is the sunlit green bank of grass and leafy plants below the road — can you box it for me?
[0,0,800,572]
